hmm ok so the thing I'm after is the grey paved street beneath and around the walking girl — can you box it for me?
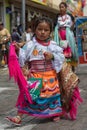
[0,66,87,130]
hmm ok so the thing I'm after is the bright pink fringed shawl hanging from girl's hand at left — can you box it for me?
[8,43,32,106]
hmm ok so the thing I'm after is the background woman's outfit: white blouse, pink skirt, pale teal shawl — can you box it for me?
[54,14,78,66]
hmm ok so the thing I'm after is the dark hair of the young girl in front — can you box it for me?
[33,17,53,32]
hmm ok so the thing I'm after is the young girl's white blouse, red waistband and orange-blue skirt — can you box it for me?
[18,38,64,117]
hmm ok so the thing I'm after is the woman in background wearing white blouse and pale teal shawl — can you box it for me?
[54,2,78,71]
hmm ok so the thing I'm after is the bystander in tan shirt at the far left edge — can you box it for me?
[0,22,11,66]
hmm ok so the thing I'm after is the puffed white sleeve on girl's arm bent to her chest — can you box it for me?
[50,43,65,73]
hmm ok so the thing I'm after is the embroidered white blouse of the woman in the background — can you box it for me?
[57,14,72,28]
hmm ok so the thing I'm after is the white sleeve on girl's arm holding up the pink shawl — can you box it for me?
[19,41,33,67]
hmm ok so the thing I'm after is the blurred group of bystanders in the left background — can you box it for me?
[0,21,33,67]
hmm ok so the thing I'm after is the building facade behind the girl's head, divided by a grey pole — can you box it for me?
[0,0,61,31]
